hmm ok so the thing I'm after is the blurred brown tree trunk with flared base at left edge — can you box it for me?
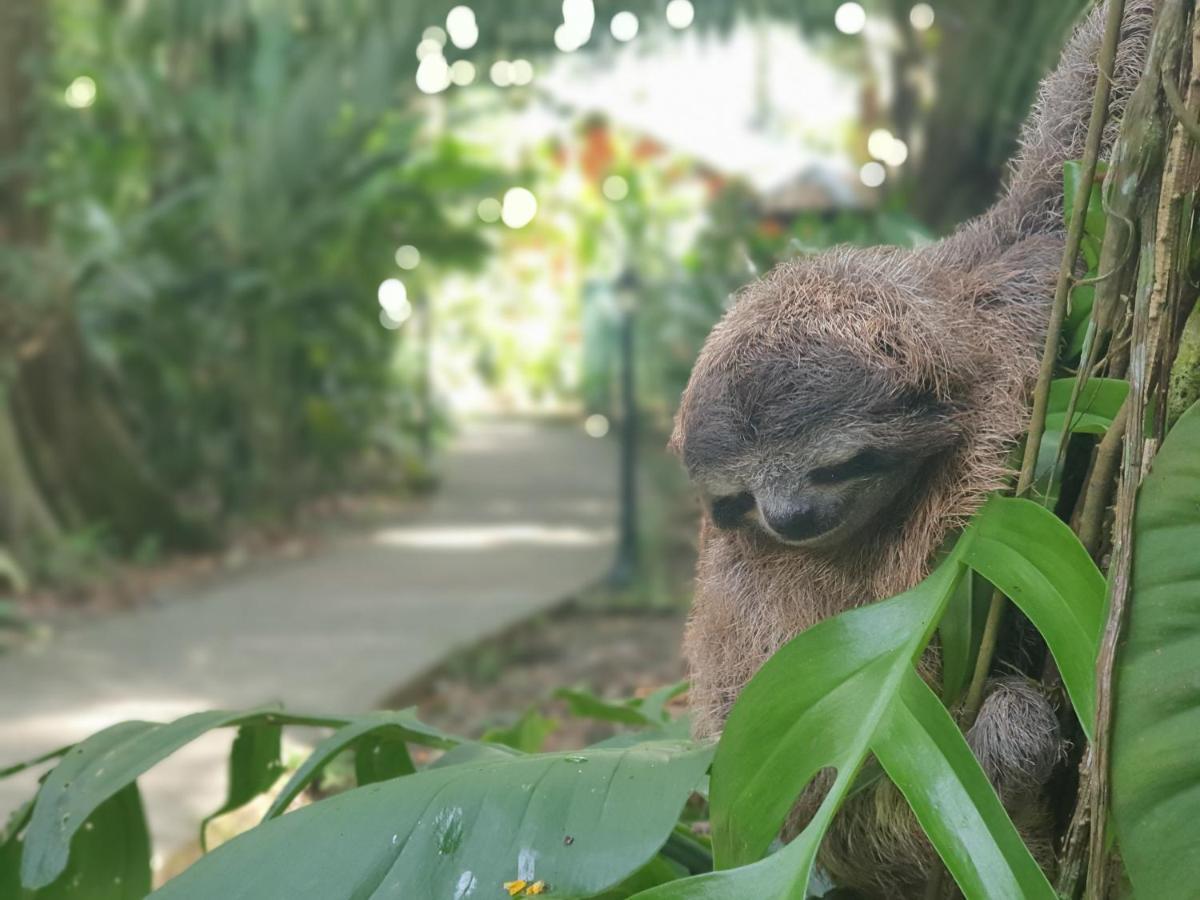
[0,2,208,564]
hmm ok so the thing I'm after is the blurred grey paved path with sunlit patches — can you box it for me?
[0,424,614,851]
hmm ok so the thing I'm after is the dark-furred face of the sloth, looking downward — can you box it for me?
[673,354,959,550]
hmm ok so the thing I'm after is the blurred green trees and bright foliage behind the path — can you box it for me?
[0,0,1084,586]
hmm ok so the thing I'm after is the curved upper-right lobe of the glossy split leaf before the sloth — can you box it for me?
[956,497,1105,736]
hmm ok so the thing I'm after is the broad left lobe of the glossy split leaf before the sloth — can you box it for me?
[710,564,965,883]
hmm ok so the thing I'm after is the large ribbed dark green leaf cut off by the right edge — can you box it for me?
[1112,406,1200,900]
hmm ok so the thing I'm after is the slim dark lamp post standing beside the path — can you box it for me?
[608,268,642,586]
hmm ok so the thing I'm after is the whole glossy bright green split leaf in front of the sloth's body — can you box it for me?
[638,498,1104,900]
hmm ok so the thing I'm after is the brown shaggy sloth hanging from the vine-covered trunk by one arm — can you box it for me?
[671,0,1153,896]
